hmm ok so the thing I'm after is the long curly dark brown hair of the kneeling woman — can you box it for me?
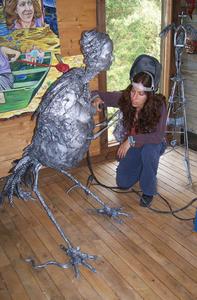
[119,72,166,133]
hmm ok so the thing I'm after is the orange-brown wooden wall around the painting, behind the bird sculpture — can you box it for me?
[0,0,100,177]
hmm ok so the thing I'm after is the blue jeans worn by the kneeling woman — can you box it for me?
[116,142,166,196]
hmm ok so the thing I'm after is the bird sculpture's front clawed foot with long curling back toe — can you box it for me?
[26,245,97,278]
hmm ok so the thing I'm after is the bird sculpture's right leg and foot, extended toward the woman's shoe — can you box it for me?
[60,170,130,223]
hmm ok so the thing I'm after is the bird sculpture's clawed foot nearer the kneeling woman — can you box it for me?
[90,205,131,223]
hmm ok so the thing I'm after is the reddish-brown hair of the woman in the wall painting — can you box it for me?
[3,0,42,29]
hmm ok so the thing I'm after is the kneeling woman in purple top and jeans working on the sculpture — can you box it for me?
[94,59,167,206]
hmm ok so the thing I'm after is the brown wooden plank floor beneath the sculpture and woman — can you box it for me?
[0,151,197,300]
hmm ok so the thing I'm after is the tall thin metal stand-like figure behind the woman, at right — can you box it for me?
[160,13,192,184]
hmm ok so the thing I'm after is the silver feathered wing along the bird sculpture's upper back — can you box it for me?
[33,68,81,117]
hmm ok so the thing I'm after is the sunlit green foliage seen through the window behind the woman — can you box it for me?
[106,0,161,91]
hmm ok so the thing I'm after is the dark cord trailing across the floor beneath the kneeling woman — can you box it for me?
[86,151,197,222]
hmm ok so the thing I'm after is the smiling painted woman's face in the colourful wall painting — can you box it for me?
[16,0,34,23]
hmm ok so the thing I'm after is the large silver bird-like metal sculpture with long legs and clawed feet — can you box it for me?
[0,30,127,276]
